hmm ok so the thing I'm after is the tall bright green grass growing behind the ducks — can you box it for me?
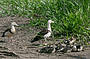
[0,0,90,43]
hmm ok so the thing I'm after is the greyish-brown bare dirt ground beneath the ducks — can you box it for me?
[0,17,90,59]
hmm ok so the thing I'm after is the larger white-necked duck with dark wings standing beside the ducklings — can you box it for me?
[31,20,54,43]
